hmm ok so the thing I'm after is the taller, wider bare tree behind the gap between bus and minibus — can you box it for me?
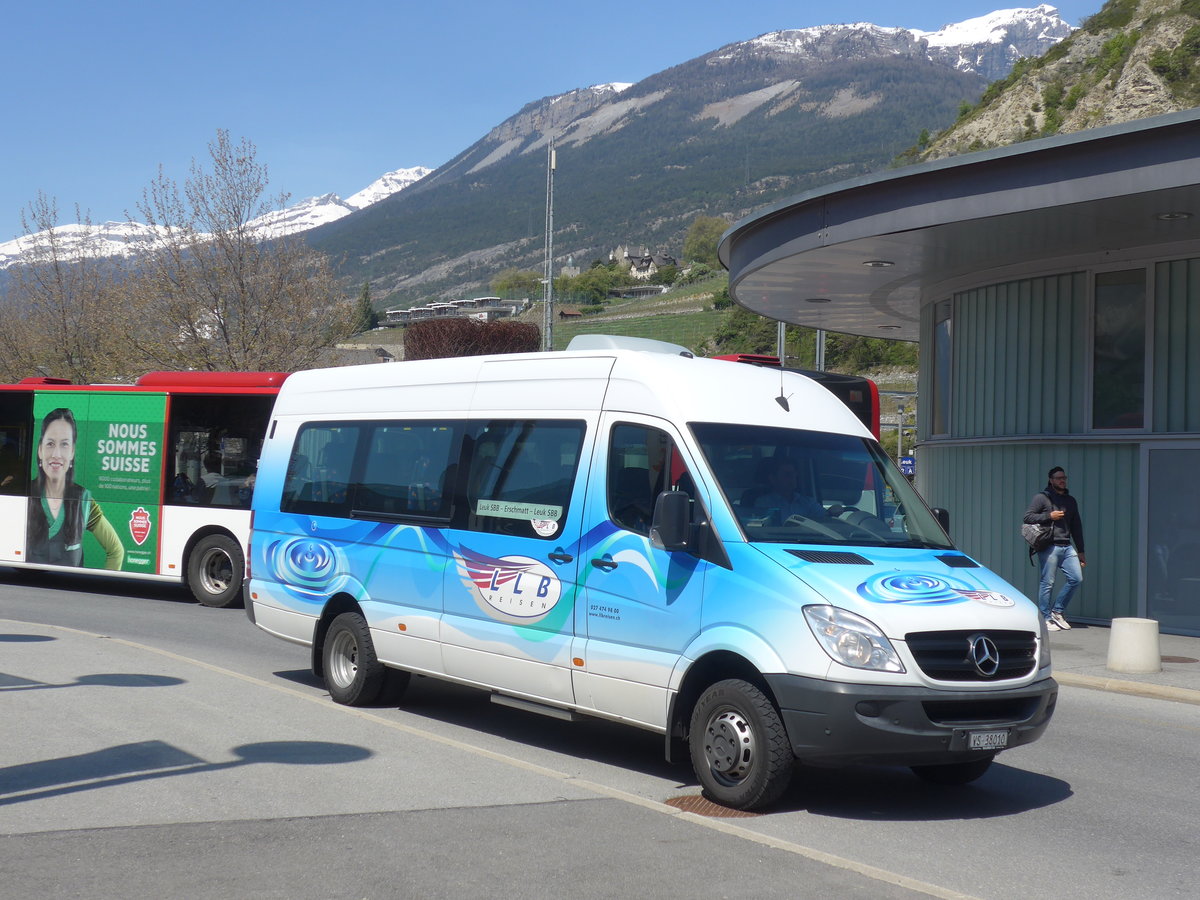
[121,131,354,371]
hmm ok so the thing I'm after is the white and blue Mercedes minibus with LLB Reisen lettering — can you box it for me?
[246,336,1057,809]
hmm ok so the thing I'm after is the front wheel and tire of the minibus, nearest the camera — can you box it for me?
[688,678,796,810]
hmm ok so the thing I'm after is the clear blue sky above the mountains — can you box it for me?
[0,0,1102,242]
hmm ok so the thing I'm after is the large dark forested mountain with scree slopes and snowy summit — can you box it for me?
[0,5,1070,305]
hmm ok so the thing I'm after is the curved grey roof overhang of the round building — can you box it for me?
[719,110,1200,341]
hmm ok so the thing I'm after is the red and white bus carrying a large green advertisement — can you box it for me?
[0,372,287,607]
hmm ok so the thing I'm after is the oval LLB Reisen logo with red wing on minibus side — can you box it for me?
[456,547,563,624]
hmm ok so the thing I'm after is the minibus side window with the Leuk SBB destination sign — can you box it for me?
[460,420,586,540]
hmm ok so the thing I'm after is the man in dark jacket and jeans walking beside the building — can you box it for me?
[1025,466,1087,631]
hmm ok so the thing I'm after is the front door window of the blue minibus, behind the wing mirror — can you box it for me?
[607,425,696,535]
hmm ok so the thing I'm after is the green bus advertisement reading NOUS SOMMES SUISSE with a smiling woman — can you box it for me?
[25,391,167,574]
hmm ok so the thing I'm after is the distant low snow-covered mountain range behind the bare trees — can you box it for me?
[0,166,432,269]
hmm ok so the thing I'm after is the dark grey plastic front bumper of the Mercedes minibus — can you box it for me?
[766,674,1058,766]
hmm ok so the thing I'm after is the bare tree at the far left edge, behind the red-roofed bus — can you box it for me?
[0,193,124,384]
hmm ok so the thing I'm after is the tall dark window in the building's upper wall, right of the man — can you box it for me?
[1092,269,1146,428]
